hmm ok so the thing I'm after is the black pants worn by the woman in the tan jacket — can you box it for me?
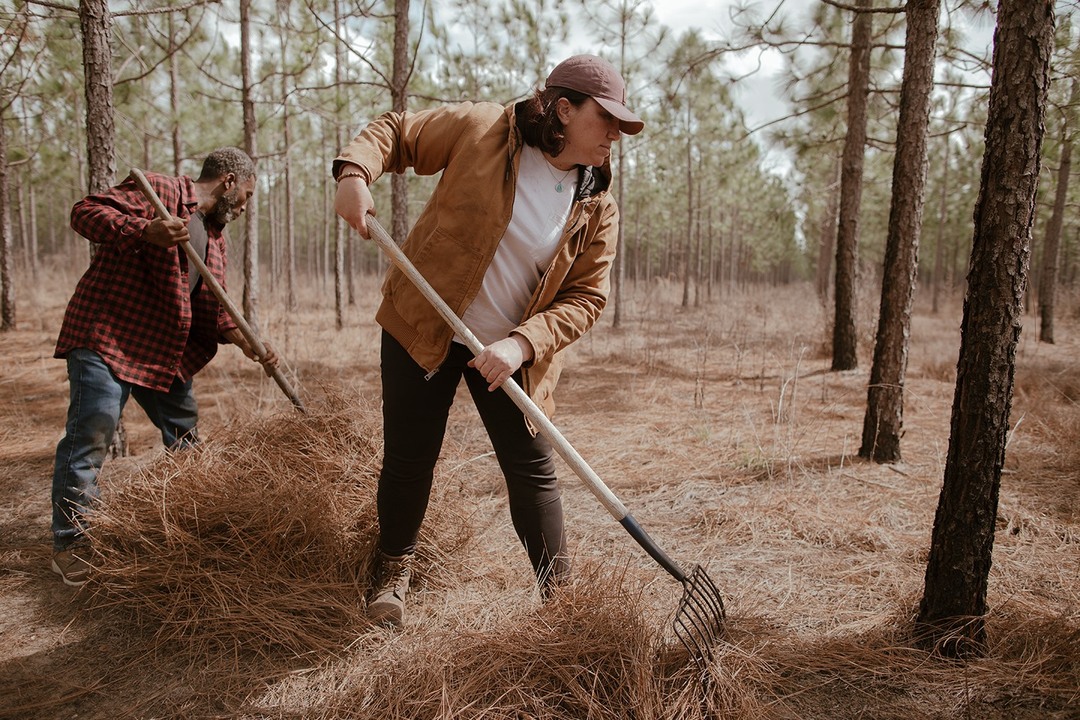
[378,332,568,586]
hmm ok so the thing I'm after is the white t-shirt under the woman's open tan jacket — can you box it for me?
[455,145,578,345]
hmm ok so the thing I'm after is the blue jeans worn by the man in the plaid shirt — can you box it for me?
[52,348,199,551]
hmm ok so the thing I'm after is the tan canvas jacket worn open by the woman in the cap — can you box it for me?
[334,103,619,416]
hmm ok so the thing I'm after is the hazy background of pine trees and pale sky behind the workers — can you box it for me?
[0,0,1080,322]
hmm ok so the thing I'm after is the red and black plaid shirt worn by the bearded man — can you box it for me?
[55,173,237,391]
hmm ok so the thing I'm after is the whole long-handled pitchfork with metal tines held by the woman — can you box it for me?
[366,215,725,671]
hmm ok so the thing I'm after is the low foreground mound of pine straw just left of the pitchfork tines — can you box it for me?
[304,566,669,720]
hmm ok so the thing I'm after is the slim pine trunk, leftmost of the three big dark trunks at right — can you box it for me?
[833,0,873,371]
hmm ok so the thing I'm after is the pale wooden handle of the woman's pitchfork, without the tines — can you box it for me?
[367,215,689,585]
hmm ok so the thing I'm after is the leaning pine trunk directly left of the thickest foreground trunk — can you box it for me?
[859,0,941,463]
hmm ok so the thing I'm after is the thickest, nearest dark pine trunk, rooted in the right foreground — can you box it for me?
[916,0,1054,656]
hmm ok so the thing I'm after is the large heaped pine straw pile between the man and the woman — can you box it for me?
[82,400,468,656]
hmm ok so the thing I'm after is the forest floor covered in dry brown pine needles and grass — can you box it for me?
[0,260,1080,720]
